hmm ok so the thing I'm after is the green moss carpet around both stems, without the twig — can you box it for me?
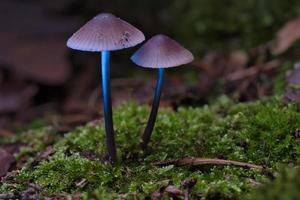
[0,96,300,199]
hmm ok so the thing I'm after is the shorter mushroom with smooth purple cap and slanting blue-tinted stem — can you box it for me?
[131,35,194,149]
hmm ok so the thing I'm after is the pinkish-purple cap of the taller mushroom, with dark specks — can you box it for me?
[67,13,145,52]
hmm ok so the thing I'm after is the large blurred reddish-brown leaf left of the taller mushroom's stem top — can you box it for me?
[7,38,71,85]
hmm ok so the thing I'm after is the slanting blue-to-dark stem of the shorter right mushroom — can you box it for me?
[141,68,165,149]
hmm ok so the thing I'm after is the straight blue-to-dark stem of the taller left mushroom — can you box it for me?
[101,51,117,163]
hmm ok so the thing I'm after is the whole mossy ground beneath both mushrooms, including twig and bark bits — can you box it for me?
[0,96,300,199]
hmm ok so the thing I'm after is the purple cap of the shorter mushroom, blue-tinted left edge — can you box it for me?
[131,35,194,68]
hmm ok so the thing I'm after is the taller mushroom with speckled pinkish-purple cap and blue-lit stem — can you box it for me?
[67,13,145,163]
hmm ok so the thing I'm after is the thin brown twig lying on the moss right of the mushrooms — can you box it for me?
[152,158,264,170]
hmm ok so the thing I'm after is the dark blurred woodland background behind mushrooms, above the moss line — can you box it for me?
[0,0,300,132]
